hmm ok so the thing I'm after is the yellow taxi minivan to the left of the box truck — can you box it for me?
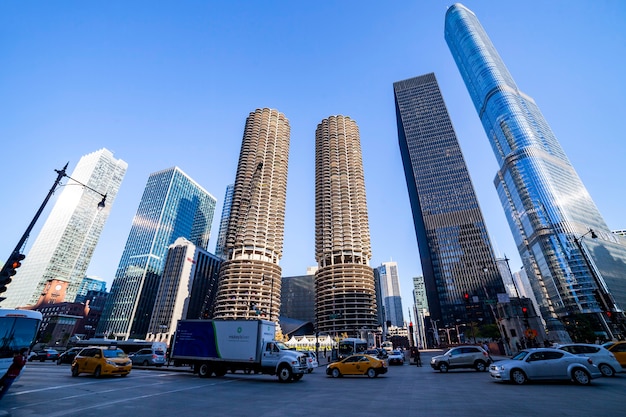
[72,346,133,378]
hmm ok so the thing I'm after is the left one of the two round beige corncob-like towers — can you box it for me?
[214,108,290,321]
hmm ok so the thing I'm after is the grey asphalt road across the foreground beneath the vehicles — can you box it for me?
[0,352,626,417]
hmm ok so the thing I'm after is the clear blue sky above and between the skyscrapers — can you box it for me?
[0,0,626,312]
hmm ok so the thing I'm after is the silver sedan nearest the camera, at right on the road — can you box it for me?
[489,348,602,385]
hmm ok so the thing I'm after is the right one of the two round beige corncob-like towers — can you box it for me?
[315,116,378,336]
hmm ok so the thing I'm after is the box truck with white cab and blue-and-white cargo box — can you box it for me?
[171,320,307,382]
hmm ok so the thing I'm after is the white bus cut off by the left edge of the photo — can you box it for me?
[0,309,41,376]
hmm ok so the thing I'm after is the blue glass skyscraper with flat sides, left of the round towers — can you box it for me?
[97,167,216,340]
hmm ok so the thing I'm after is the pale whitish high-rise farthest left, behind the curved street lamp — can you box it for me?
[2,149,128,308]
